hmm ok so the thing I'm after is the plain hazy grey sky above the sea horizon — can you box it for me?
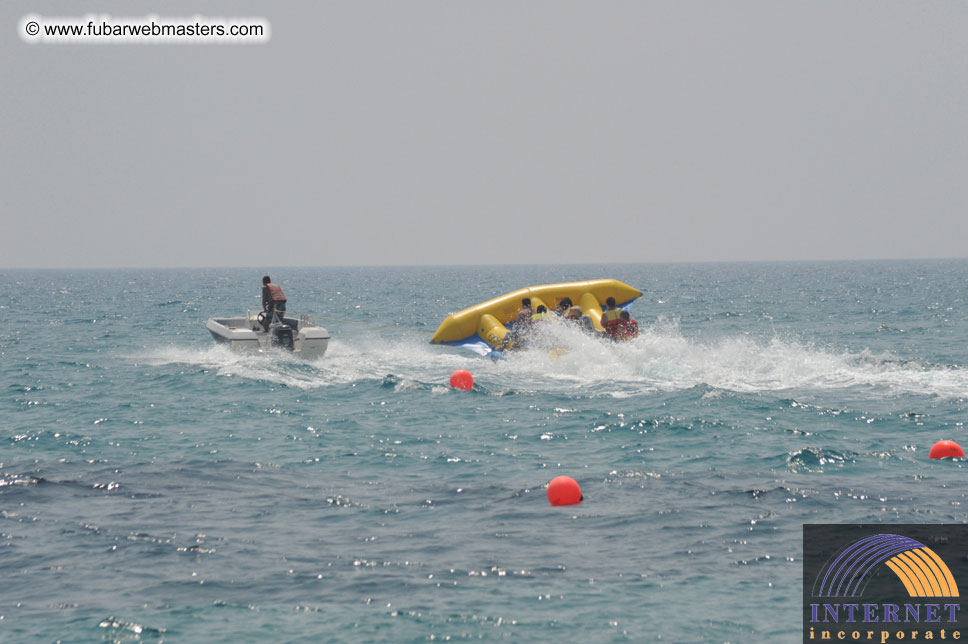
[0,0,968,268]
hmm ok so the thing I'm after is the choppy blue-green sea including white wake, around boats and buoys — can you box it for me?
[0,260,968,642]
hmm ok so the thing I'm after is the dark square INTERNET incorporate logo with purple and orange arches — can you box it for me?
[803,525,968,644]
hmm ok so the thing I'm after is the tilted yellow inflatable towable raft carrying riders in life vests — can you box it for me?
[430,279,642,354]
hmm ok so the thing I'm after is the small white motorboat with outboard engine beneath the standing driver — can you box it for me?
[205,310,329,360]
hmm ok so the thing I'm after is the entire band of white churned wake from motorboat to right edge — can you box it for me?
[136,319,968,398]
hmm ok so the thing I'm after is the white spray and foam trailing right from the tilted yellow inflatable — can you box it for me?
[458,319,968,398]
